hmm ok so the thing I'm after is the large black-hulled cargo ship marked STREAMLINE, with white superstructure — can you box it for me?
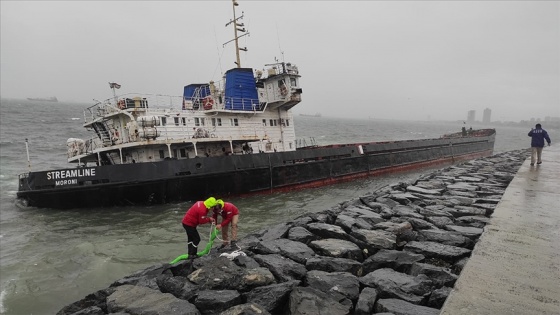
[17,1,495,209]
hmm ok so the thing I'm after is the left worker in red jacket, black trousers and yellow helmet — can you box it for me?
[182,197,217,259]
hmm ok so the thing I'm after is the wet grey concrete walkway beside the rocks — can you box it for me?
[440,145,560,315]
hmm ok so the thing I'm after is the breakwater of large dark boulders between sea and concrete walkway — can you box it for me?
[58,150,528,314]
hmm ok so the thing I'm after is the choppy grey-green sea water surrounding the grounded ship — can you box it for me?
[0,100,544,314]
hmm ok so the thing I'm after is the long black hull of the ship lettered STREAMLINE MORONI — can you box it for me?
[17,133,495,209]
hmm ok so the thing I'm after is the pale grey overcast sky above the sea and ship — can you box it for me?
[0,0,560,121]
